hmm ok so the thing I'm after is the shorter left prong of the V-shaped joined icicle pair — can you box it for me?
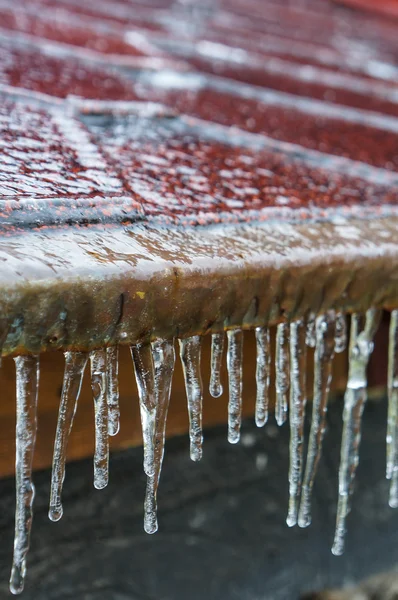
[130,344,156,477]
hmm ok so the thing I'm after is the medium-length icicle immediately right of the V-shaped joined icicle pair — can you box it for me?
[179,335,203,461]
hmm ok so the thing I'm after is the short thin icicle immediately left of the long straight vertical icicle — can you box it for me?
[275,323,290,425]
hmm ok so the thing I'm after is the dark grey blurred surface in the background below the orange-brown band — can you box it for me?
[0,400,398,600]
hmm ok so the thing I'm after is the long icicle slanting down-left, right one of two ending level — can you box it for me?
[298,311,335,527]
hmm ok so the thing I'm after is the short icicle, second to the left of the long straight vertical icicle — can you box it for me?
[256,327,271,427]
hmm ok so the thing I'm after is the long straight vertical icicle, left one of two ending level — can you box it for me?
[286,320,307,527]
